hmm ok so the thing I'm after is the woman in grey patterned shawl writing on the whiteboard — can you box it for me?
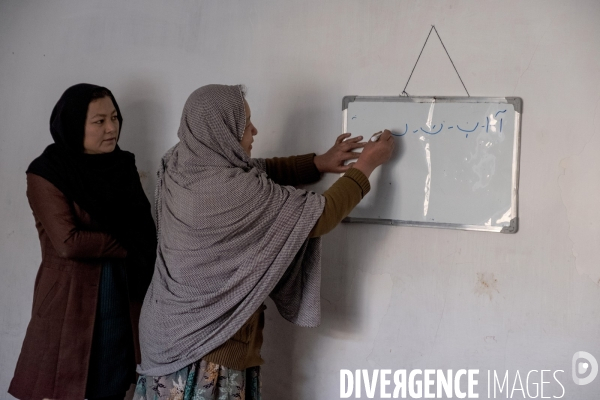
[135,85,394,399]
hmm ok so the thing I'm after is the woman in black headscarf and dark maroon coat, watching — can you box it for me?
[9,84,156,399]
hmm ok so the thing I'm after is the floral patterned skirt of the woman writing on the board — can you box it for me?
[133,360,261,400]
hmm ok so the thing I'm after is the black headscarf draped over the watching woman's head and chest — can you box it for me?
[27,83,156,299]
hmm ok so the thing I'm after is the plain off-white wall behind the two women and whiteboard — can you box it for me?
[0,0,600,400]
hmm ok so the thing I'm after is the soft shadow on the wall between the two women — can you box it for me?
[117,79,167,214]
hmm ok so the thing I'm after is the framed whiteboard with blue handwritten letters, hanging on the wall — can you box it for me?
[343,96,522,233]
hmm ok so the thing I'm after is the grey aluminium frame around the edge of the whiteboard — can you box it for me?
[342,96,523,233]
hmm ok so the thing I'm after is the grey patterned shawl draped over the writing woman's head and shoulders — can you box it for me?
[138,85,325,376]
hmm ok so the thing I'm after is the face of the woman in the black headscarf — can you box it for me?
[83,97,119,154]
